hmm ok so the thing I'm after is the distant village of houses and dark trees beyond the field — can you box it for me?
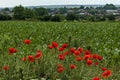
[0,4,120,21]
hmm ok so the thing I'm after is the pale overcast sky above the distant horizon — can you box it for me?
[0,0,120,7]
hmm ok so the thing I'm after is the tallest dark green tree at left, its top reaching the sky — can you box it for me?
[13,5,24,20]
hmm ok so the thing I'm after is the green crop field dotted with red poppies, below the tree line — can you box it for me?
[0,21,120,80]
